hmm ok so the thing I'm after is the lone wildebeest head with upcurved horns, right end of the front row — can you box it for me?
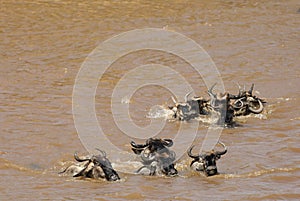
[187,142,227,176]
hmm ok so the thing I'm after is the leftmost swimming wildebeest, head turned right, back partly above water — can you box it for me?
[60,149,120,181]
